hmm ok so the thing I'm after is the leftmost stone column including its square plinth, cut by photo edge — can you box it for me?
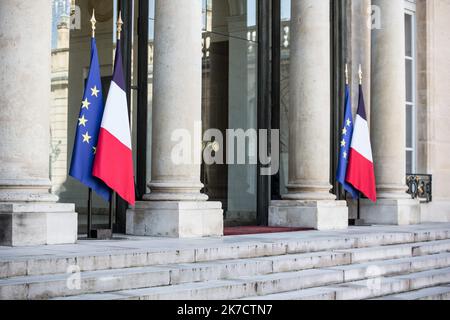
[0,0,77,246]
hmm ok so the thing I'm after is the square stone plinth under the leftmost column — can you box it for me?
[0,203,78,247]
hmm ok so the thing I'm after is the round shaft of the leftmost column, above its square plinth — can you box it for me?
[0,0,57,202]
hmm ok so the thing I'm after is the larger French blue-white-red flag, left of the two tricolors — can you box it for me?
[92,40,136,205]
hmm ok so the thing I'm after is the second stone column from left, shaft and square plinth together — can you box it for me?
[127,0,223,237]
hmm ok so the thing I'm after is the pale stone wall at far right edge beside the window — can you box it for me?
[417,0,450,221]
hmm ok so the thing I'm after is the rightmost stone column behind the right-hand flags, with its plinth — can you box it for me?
[361,0,420,224]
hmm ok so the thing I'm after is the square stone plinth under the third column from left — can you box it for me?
[269,200,348,231]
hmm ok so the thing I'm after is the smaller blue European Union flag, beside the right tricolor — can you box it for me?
[337,85,359,199]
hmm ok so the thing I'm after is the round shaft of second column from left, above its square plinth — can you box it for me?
[145,0,207,201]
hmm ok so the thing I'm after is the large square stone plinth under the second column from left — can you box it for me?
[127,201,223,238]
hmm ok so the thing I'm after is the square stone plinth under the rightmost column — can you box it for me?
[360,199,420,226]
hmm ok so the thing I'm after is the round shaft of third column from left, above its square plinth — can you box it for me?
[284,0,336,200]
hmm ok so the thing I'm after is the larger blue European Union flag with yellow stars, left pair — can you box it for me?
[69,38,111,201]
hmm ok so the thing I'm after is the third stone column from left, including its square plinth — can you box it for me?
[270,0,348,230]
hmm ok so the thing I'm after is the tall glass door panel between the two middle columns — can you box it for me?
[202,0,258,226]
